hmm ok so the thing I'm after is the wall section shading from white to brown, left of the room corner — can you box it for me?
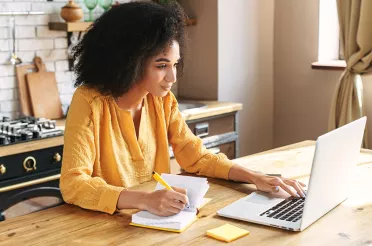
[218,0,274,155]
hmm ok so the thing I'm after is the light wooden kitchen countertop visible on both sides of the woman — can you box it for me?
[0,101,243,157]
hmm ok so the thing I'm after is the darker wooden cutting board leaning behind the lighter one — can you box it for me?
[16,61,45,116]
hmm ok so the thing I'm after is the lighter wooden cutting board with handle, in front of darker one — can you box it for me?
[26,57,63,119]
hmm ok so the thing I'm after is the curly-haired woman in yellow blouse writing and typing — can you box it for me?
[60,2,304,216]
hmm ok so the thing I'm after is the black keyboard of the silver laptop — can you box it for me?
[260,197,305,222]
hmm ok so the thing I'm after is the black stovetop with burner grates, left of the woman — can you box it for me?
[0,116,63,146]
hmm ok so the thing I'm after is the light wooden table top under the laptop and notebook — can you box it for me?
[0,141,372,246]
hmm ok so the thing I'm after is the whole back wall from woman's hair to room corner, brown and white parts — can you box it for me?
[178,0,274,156]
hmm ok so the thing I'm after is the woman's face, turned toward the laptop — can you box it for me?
[138,41,180,97]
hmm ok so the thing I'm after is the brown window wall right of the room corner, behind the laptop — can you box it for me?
[274,0,372,147]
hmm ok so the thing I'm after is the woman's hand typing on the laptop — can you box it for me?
[252,173,306,197]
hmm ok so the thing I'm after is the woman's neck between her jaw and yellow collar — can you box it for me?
[116,85,148,111]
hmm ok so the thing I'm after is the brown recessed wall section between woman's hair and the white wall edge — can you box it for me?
[178,0,218,100]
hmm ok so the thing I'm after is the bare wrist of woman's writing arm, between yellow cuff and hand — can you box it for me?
[116,190,148,210]
